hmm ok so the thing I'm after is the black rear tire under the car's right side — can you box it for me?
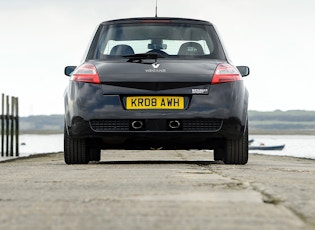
[223,121,248,165]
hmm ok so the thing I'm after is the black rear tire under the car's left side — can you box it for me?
[64,127,89,164]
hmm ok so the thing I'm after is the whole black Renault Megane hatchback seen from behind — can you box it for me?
[64,17,249,164]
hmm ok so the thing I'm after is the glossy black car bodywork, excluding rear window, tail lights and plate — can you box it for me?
[65,18,249,164]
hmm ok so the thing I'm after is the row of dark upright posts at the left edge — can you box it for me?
[0,94,19,157]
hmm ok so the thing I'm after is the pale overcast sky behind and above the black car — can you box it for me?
[0,0,315,116]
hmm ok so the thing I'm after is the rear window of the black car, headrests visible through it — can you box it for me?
[91,23,225,59]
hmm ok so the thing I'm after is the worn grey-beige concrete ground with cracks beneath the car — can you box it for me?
[0,150,315,229]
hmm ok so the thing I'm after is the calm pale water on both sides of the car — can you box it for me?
[0,134,315,160]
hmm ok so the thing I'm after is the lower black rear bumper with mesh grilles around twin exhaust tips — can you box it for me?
[68,117,245,149]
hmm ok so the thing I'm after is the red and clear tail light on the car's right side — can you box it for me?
[211,64,242,85]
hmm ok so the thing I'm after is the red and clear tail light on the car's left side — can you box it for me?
[71,63,101,84]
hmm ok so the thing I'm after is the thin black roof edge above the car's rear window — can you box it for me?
[101,17,212,25]
